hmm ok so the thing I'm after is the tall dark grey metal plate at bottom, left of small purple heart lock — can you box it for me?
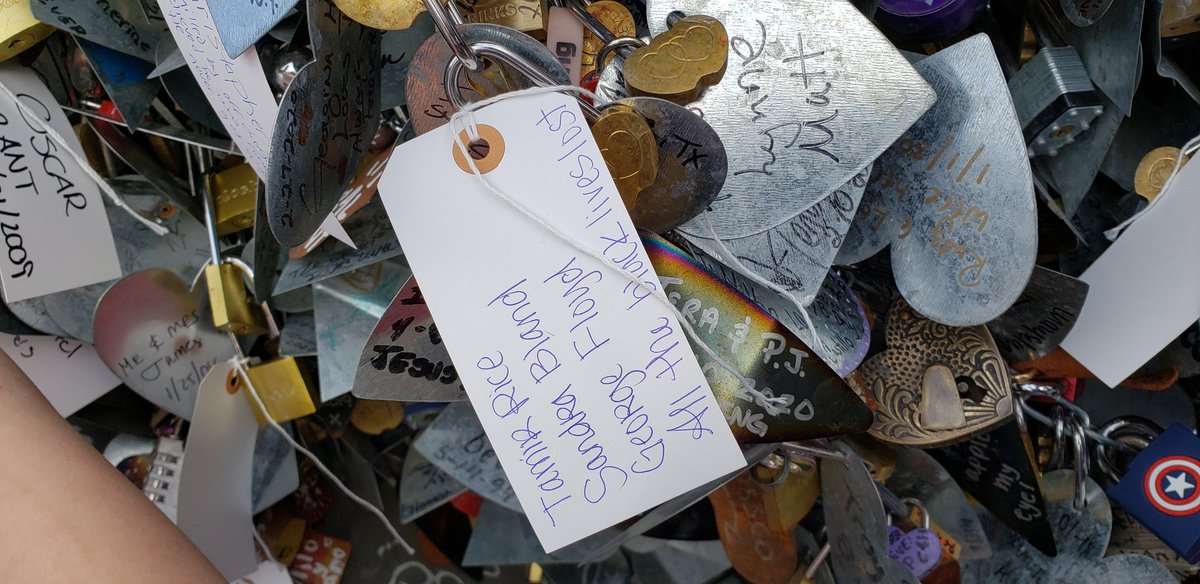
[820,444,918,584]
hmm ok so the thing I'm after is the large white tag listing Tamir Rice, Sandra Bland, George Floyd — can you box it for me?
[379,94,745,552]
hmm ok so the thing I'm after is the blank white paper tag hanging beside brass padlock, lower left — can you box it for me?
[175,361,258,580]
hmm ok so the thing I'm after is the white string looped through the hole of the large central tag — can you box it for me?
[450,85,787,415]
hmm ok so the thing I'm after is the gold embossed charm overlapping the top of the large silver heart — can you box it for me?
[624,14,730,106]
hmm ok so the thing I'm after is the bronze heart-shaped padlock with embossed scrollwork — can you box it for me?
[858,300,1014,446]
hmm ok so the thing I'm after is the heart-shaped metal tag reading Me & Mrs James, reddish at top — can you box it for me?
[92,269,235,420]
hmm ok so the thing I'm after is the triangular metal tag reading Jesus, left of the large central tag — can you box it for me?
[352,278,467,402]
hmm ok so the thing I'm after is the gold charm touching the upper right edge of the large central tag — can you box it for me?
[592,112,659,211]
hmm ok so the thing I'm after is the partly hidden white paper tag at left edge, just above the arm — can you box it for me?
[0,333,121,417]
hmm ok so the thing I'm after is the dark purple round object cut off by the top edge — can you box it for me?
[875,0,988,43]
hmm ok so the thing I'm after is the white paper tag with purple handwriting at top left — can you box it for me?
[158,0,280,176]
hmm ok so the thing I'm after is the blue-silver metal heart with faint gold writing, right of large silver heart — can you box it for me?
[838,34,1038,326]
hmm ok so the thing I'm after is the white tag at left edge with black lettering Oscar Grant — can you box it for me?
[0,62,121,302]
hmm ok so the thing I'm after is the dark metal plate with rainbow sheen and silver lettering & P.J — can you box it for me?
[641,231,874,442]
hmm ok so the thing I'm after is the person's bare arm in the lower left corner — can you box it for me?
[0,351,226,584]
